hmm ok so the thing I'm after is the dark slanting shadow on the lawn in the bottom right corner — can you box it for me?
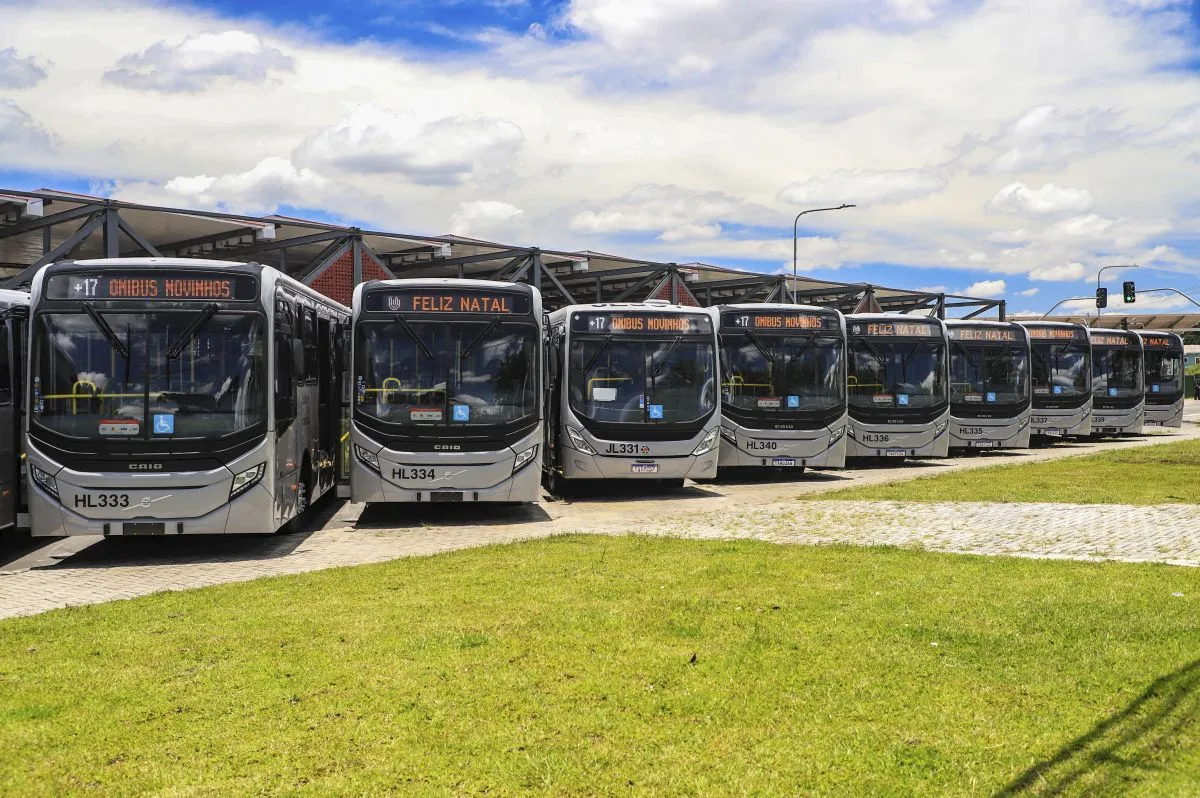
[996,660,1200,798]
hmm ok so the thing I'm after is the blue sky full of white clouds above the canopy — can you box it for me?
[0,0,1200,312]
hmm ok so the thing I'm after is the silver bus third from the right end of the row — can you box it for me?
[1019,322,1092,438]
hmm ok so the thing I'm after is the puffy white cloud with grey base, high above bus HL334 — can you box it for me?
[296,104,524,185]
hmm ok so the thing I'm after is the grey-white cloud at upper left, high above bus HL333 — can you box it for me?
[104,30,293,92]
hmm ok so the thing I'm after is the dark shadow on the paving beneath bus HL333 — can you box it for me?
[36,492,346,570]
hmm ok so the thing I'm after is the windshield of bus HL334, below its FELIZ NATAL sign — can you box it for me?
[354,317,538,427]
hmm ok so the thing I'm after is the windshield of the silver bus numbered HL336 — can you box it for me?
[850,338,946,409]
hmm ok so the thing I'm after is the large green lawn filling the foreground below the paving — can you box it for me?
[0,536,1200,796]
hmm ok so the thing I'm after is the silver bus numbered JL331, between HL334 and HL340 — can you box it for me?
[544,300,721,494]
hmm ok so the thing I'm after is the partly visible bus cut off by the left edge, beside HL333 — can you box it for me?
[0,289,29,530]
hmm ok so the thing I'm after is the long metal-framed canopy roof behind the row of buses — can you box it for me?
[0,190,1004,319]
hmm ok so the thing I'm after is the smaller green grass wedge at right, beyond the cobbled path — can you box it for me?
[816,440,1200,504]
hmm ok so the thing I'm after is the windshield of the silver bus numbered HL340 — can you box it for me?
[721,331,846,416]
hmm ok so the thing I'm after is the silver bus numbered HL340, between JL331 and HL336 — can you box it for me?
[713,304,848,469]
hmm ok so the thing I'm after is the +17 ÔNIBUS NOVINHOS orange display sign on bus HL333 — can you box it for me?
[46,271,258,301]
